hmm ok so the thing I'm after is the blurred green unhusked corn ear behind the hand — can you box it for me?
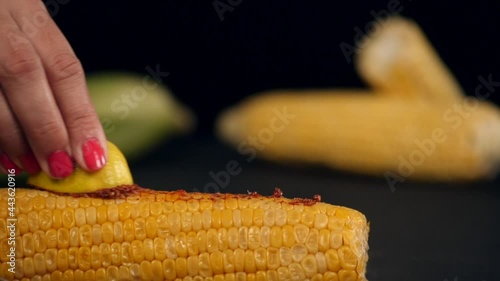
[87,72,196,161]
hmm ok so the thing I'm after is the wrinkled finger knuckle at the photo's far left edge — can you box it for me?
[2,48,41,77]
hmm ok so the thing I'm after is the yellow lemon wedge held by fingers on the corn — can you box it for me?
[28,141,133,193]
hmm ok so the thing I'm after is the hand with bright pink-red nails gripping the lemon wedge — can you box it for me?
[0,0,107,178]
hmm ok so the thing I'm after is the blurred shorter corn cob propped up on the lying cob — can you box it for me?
[355,17,464,104]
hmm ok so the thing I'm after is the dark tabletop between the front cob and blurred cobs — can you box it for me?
[130,136,500,281]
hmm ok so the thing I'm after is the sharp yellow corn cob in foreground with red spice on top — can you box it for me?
[0,188,369,281]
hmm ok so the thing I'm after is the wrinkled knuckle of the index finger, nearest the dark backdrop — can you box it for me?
[48,52,84,82]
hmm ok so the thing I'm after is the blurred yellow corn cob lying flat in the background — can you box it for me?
[218,90,500,182]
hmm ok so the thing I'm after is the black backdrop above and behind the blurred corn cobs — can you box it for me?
[53,0,500,133]
